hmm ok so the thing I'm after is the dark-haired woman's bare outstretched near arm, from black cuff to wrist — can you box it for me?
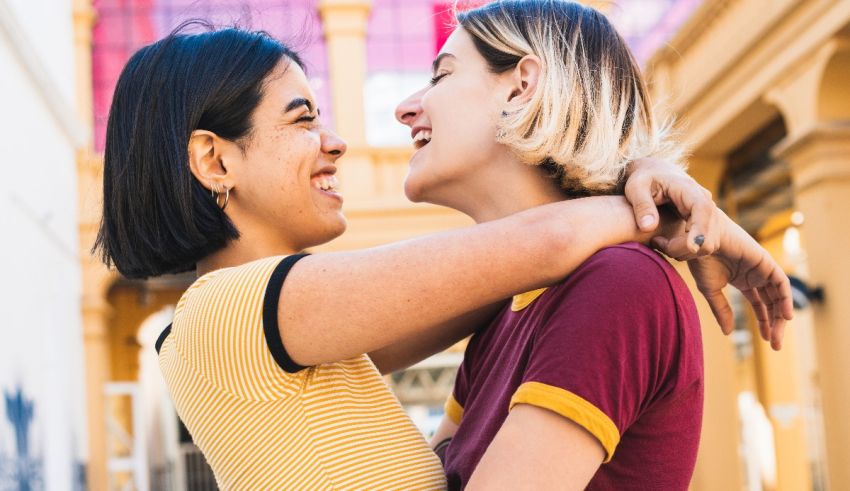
[279,197,639,365]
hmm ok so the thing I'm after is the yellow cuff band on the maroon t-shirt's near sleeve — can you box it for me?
[508,382,620,462]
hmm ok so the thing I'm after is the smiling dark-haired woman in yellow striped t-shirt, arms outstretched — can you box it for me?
[96,21,782,489]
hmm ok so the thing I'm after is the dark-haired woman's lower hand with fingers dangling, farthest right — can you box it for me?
[653,210,794,350]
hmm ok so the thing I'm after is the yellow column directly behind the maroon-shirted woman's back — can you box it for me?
[674,156,743,491]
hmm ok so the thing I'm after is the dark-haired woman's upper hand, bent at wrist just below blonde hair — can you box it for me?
[625,159,719,260]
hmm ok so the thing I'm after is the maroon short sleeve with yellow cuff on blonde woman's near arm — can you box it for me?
[510,248,679,462]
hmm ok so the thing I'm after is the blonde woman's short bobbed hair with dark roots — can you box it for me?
[455,0,682,195]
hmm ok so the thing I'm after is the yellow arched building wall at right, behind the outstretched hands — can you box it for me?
[647,0,850,490]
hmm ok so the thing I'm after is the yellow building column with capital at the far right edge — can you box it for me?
[778,122,850,489]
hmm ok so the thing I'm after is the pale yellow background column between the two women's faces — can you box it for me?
[319,0,376,200]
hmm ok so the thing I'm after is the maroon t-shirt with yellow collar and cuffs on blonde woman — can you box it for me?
[445,244,703,491]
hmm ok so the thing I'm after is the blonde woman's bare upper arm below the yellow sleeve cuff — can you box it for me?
[466,404,605,491]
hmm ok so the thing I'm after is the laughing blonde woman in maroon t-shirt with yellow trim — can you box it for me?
[396,0,787,491]
